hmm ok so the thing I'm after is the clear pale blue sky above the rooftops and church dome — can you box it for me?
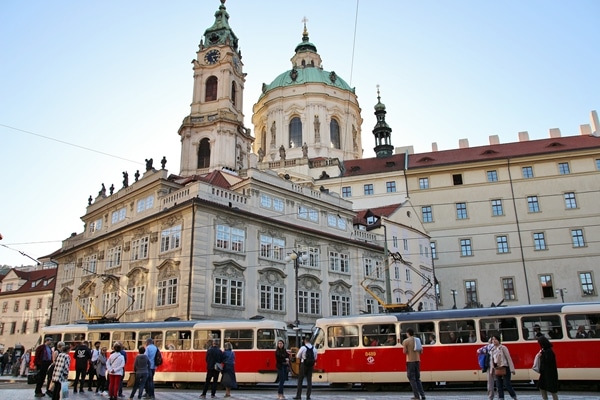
[0,0,600,266]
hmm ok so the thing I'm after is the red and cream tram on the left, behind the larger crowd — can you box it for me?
[42,319,288,387]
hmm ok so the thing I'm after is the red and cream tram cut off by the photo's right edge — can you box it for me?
[313,303,600,385]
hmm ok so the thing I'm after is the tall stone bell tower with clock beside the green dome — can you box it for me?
[178,0,254,176]
